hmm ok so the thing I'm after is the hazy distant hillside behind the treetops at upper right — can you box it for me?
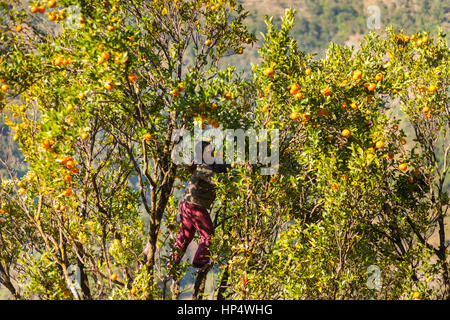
[227,0,450,72]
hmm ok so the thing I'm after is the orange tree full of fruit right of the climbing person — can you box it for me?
[215,11,450,299]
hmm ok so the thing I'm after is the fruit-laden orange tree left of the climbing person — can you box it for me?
[0,0,255,299]
